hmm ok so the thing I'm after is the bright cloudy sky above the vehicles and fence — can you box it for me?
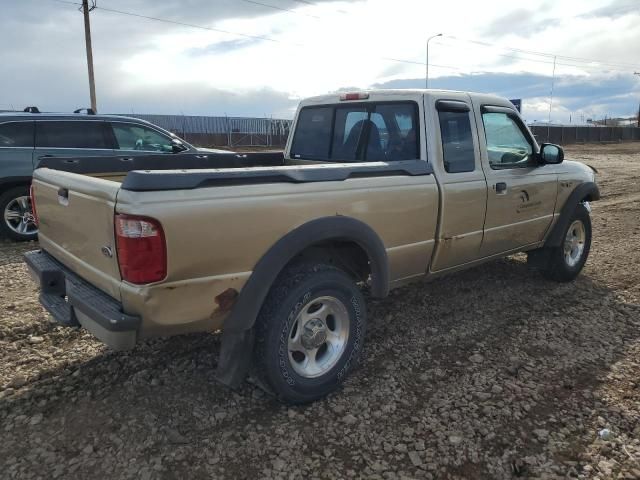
[0,0,640,122]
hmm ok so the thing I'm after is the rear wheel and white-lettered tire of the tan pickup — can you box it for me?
[254,264,366,404]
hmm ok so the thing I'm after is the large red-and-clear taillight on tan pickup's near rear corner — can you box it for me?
[115,214,167,285]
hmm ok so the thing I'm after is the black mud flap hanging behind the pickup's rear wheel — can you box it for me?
[216,328,254,388]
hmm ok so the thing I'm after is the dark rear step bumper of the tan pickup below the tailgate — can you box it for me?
[24,250,142,350]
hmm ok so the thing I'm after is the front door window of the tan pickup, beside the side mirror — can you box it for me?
[482,112,534,169]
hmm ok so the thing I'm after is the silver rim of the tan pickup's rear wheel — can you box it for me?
[288,296,350,378]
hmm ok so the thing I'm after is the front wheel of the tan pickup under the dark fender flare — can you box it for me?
[528,203,591,282]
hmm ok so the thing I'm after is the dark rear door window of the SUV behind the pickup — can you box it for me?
[36,120,113,149]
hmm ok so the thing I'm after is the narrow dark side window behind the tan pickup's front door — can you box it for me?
[438,111,476,173]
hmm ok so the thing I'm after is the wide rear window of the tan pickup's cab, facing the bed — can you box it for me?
[291,102,419,162]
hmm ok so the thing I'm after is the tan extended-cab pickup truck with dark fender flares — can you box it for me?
[26,90,599,403]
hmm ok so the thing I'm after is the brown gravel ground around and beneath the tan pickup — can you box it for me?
[0,144,640,479]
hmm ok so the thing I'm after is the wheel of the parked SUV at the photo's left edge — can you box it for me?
[0,185,38,241]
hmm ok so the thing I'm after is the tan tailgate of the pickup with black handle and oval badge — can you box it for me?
[32,168,121,299]
